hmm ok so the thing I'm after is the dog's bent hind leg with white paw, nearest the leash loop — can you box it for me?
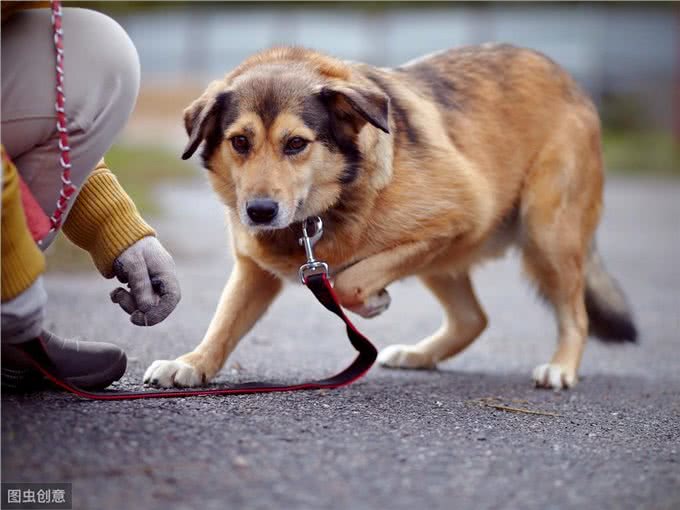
[378,273,487,368]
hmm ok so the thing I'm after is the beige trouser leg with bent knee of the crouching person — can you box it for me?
[1,8,140,248]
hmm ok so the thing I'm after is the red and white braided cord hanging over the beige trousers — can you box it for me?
[42,0,77,241]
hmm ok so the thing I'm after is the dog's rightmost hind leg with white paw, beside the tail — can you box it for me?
[520,128,602,389]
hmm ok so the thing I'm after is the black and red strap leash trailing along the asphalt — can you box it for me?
[15,273,378,400]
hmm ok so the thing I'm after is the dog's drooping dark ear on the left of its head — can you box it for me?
[182,82,231,159]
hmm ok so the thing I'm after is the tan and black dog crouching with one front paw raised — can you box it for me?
[144,44,637,389]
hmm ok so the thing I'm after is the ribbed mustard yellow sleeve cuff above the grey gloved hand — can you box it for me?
[63,159,156,278]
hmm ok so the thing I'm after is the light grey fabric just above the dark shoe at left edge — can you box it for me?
[1,276,47,344]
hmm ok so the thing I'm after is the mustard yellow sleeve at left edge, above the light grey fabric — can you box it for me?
[0,149,45,302]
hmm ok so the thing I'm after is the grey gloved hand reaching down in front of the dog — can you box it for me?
[111,236,181,326]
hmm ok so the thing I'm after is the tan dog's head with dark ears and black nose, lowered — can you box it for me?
[182,48,389,230]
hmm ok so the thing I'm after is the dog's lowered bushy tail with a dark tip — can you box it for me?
[585,241,638,343]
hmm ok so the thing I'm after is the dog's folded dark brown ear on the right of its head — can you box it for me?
[319,85,390,133]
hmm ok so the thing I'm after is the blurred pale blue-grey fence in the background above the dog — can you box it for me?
[102,3,680,135]
